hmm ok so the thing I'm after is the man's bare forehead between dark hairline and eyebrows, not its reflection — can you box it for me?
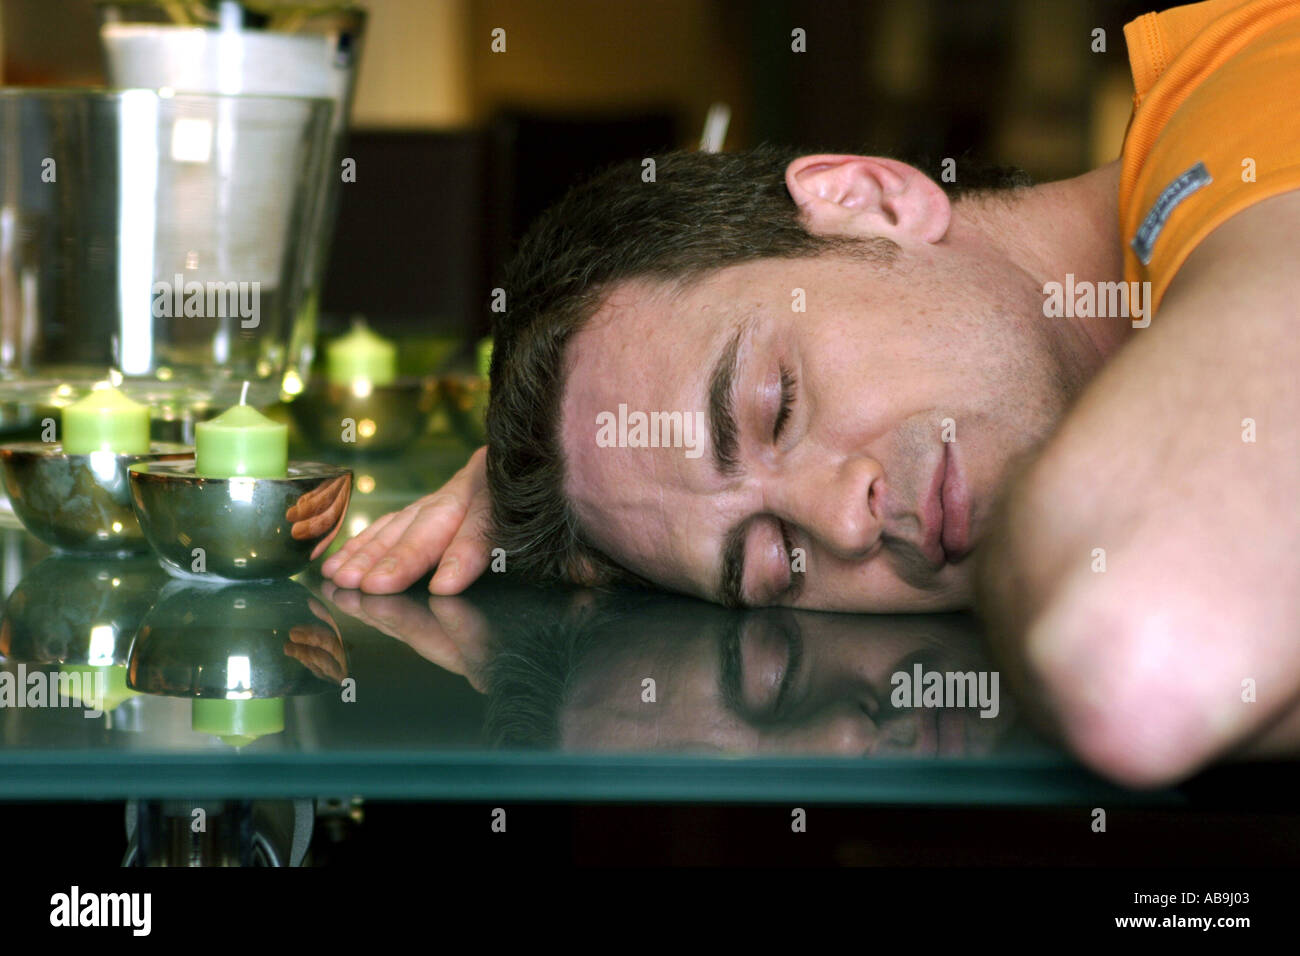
[560,273,762,593]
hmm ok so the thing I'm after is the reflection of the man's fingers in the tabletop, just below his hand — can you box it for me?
[321,581,489,693]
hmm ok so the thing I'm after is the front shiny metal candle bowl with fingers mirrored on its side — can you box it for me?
[130,460,352,580]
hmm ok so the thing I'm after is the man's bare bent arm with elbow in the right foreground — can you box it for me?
[979,193,1300,786]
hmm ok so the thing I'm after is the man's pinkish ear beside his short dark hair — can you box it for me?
[785,153,953,243]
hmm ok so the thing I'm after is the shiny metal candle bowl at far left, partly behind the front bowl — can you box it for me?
[0,441,194,554]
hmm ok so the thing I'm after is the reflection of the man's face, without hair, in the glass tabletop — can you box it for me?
[558,600,1015,756]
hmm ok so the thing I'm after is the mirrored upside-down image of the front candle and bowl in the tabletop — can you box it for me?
[126,581,347,747]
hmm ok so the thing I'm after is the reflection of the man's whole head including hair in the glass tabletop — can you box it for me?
[485,591,1024,757]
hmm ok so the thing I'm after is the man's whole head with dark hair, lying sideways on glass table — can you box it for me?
[488,150,1096,611]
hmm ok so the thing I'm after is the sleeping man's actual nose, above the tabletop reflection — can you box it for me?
[766,453,884,561]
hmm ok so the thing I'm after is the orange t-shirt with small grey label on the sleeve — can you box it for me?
[1119,0,1300,310]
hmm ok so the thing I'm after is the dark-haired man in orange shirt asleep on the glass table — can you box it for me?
[325,0,1300,784]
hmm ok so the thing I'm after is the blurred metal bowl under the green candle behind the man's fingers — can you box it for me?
[289,376,438,451]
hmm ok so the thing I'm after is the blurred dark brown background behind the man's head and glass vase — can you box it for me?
[0,0,1153,341]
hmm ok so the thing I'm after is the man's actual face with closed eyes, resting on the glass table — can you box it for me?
[562,163,1074,611]
